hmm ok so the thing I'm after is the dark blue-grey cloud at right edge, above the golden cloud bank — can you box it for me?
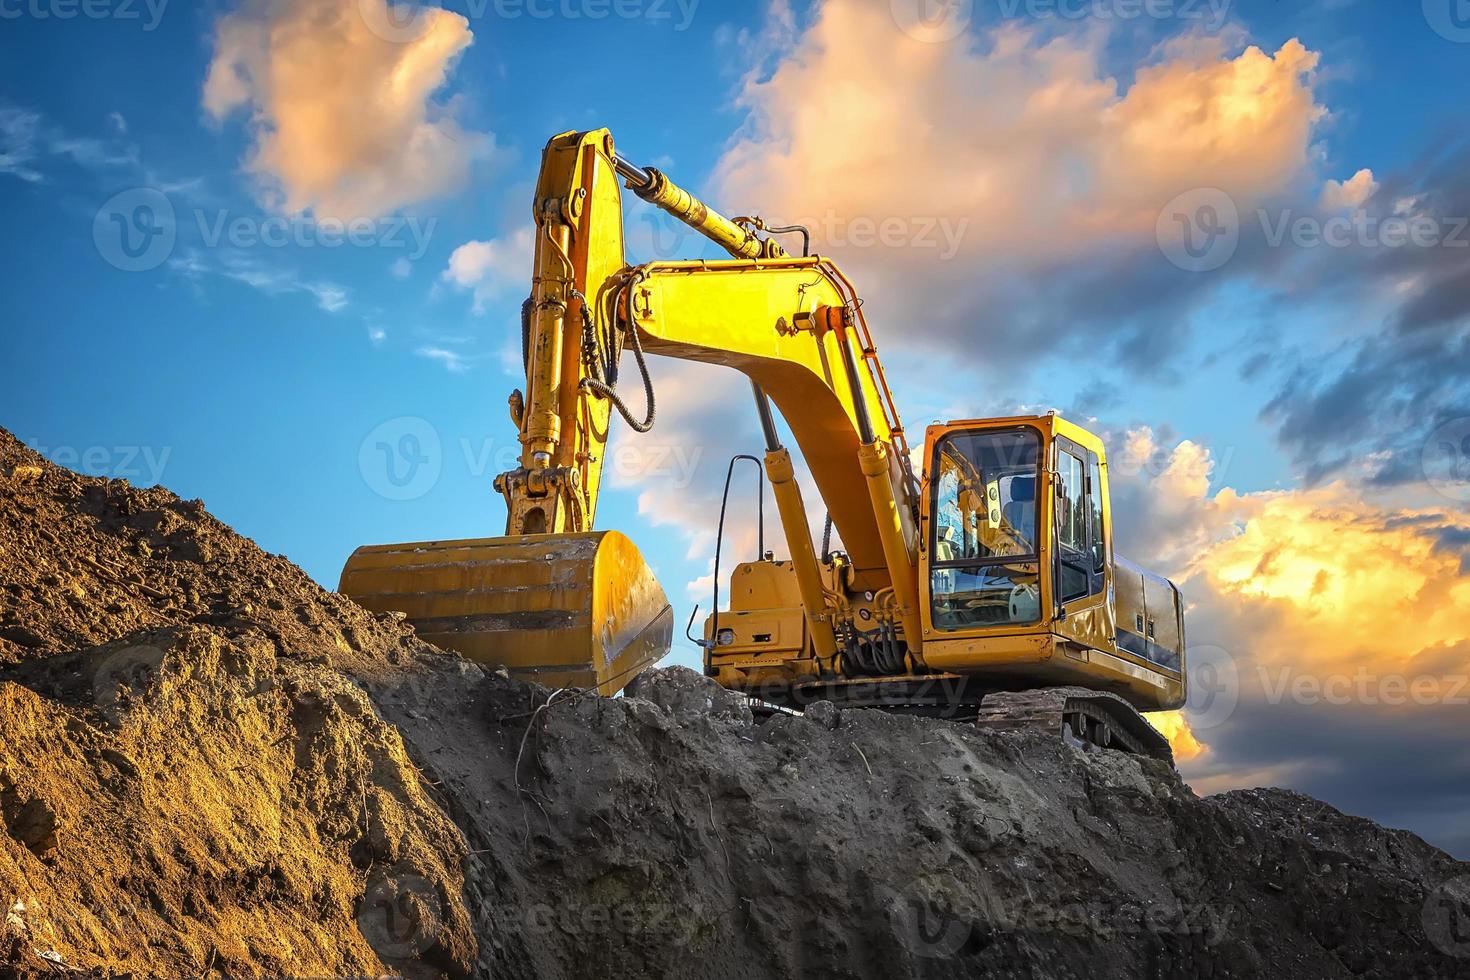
[1263,144,1470,486]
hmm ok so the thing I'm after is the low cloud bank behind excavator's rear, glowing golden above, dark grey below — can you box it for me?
[1110,429,1470,855]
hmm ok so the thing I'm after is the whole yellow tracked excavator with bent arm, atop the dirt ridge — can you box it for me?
[341,129,1185,758]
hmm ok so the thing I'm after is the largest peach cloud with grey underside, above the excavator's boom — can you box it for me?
[714,3,1324,370]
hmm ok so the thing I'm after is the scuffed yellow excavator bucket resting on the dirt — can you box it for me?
[338,530,673,695]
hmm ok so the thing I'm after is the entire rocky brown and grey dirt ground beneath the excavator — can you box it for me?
[0,430,1470,980]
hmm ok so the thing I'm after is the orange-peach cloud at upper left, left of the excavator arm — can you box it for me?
[203,0,492,219]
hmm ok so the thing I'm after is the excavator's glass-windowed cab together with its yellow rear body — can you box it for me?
[919,414,1185,711]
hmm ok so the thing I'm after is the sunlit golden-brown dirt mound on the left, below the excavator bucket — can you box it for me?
[0,432,476,976]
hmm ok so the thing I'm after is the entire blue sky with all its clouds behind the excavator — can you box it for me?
[0,0,1470,857]
